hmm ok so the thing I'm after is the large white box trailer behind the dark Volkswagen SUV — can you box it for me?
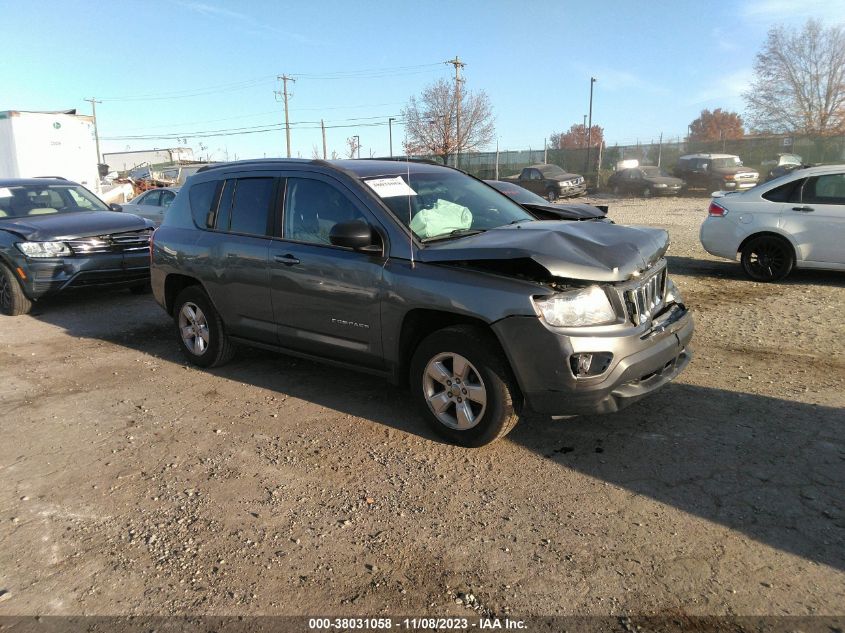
[0,110,100,193]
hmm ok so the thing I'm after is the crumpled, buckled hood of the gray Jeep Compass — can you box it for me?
[417,221,669,282]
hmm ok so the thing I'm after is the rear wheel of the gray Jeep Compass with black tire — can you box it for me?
[173,286,236,367]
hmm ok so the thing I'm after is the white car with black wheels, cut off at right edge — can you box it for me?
[699,165,845,281]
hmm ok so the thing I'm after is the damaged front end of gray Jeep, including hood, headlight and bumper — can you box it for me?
[412,222,693,416]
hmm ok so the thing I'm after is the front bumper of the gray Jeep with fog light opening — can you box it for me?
[493,305,694,415]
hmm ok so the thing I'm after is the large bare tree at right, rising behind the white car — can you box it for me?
[743,20,845,135]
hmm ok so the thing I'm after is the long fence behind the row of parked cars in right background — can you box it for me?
[428,136,845,185]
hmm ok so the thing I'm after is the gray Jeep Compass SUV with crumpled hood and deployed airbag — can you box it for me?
[151,159,693,446]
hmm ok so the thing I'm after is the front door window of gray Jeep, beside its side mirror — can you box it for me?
[284,178,365,244]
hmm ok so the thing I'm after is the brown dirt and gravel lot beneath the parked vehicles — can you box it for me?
[0,198,845,616]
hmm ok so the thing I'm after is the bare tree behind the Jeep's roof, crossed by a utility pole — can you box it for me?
[402,79,495,163]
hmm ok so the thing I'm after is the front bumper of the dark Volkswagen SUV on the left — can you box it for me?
[15,251,150,300]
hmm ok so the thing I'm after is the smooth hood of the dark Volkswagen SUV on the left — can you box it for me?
[0,211,154,242]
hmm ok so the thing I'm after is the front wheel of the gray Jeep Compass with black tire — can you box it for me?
[410,325,520,448]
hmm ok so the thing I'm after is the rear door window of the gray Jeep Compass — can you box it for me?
[217,178,276,235]
